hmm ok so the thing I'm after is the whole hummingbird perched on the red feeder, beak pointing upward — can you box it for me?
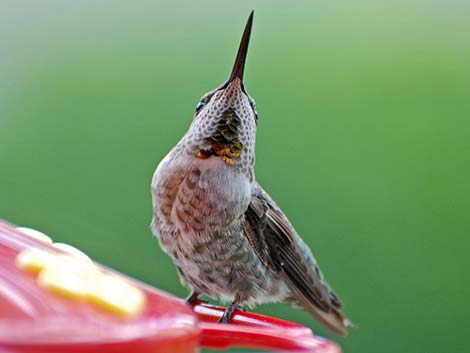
[151,11,349,336]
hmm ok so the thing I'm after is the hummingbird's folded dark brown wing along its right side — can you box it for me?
[243,186,348,336]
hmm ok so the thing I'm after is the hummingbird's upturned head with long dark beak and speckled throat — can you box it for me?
[184,11,258,176]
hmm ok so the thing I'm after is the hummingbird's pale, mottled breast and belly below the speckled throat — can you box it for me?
[152,157,287,304]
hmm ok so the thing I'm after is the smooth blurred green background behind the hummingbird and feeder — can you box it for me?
[0,0,470,353]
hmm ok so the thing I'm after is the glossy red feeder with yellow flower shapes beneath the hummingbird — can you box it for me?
[0,221,341,353]
